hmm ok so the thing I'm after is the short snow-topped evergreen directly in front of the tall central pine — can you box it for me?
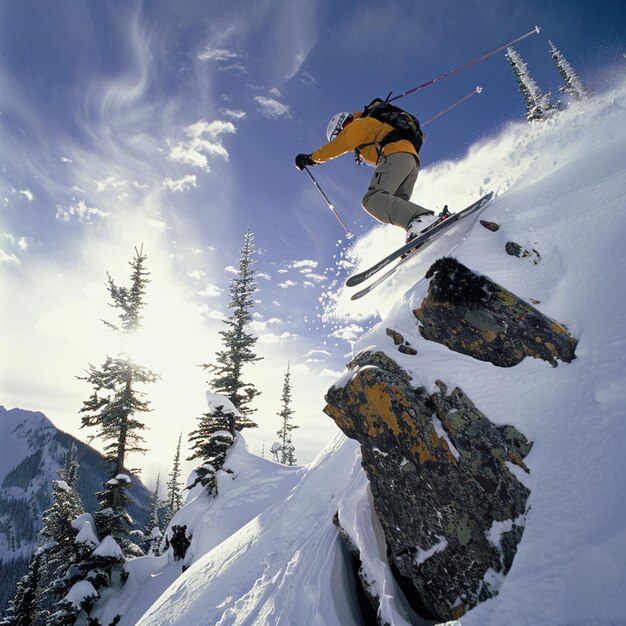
[187,405,238,496]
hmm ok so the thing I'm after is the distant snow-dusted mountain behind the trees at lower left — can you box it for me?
[0,406,151,613]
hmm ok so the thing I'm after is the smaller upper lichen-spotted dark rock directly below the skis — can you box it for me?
[414,258,577,367]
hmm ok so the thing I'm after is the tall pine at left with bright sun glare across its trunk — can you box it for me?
[79,247,157,556]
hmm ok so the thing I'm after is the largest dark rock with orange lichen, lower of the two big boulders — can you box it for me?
[325,352,531,620]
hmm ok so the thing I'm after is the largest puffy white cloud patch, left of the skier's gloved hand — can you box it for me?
[169,120,237,171]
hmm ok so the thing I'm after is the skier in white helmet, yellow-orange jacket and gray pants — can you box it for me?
[296,100,436,242]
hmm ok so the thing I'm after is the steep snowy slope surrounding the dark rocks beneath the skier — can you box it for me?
[109,79,626,626]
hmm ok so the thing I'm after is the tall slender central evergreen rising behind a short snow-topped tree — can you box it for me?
[203,230,262,424]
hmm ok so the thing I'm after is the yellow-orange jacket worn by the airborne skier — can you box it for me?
[311,112,419,165]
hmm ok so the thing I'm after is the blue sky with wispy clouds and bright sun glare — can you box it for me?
[0,0,626,476]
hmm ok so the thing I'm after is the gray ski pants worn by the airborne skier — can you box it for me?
[361,152,432,228]
